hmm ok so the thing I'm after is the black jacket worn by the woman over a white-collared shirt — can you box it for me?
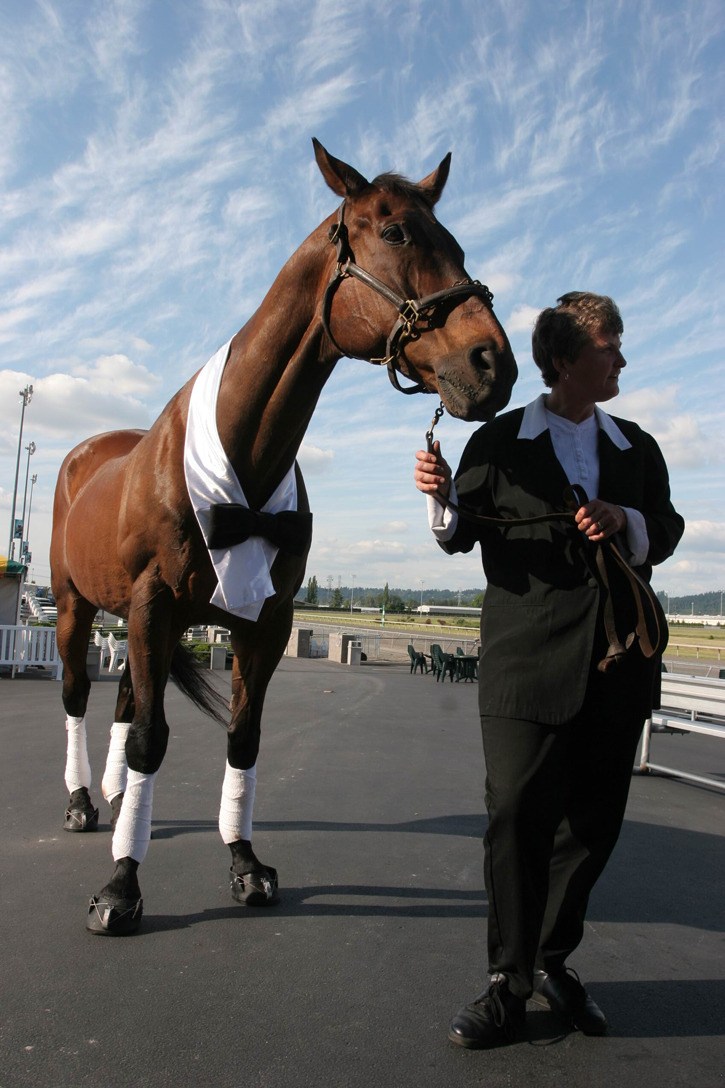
[441,408,685,725]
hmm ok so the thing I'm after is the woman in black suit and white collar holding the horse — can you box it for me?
[415,292,684,1048]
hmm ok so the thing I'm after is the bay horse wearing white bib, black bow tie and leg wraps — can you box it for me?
[51,139,517,936]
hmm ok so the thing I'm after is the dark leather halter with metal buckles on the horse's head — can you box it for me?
[322,200,493,393]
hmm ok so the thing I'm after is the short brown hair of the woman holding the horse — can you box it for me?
[531,290,624,387]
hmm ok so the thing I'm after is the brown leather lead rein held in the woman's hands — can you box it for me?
[426,401,667,672]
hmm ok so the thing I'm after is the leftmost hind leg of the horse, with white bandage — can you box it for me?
[56,590,98,831]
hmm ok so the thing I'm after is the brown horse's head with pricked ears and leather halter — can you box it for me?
[314,140,518,420]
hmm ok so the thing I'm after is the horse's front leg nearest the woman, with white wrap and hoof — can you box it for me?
[219,602,292,906]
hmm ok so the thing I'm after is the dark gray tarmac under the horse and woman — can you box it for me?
[0,658,725,1088]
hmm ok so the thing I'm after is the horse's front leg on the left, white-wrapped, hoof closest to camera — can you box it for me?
[86,583,172,937]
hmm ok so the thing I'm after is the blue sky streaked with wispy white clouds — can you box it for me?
[0,0,725,595]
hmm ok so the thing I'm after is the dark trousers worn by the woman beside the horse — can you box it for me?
[481,668,643,998]
